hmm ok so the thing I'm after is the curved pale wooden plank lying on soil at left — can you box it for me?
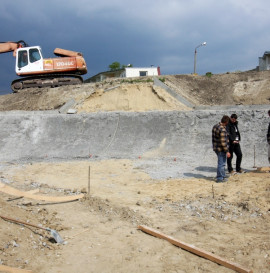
[0,182,84,203]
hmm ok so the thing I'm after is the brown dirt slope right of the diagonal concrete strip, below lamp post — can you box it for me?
[166,71,270,105]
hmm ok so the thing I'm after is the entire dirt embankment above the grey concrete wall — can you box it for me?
[0,71,270,112]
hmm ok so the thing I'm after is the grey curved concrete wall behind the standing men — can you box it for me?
[0,105,269,167]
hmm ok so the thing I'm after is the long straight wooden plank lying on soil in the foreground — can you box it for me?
[138,225,252,273]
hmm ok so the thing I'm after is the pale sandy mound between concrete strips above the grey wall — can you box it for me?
[76,83,189,113]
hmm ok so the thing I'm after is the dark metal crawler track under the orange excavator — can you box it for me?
[11,74,83,93]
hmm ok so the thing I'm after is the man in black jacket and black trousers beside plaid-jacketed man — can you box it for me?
[226,114,244,174]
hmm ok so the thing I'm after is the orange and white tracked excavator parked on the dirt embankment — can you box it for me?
[0,40,87,93]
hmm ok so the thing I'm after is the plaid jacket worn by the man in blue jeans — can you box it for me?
[212,123,229,153]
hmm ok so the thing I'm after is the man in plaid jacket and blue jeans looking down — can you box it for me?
[212,116,231,183]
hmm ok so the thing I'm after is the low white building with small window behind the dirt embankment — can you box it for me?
[85,66,160,82]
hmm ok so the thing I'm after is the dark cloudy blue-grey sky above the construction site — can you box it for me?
[0,0,270,95]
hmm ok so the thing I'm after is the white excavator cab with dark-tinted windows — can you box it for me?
[16,46,43,75]
